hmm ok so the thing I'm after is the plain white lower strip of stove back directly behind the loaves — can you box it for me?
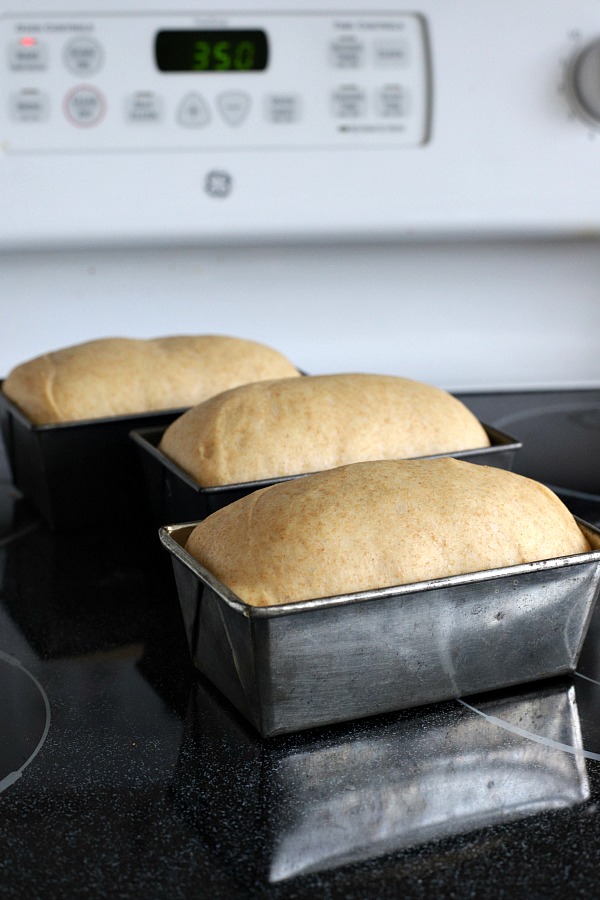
[0,238,600,390]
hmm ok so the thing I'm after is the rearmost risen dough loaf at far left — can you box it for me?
[3,335,300,425]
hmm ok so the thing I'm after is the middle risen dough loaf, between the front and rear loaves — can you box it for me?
[160,374,489,487]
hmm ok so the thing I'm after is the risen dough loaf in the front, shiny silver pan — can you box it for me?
[186,458,590,606]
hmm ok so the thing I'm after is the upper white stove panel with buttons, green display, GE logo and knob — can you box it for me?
[0,0,600,251]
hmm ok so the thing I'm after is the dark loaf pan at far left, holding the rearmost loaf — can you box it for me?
[0,382,184,530]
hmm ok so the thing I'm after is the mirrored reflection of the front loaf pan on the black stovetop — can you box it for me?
[173,679,590,883]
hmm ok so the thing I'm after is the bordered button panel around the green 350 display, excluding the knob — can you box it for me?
[0,13,431,154]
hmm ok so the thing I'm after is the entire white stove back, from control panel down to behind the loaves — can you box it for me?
[0,0,600,391]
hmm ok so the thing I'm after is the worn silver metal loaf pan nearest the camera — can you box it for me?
[160,519,600,737]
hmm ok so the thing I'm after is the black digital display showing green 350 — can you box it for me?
[155,30,269,72]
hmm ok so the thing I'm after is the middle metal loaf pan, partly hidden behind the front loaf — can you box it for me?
[136,423,522,526]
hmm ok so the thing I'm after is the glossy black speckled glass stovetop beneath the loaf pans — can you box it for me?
[0,391,600,900]
